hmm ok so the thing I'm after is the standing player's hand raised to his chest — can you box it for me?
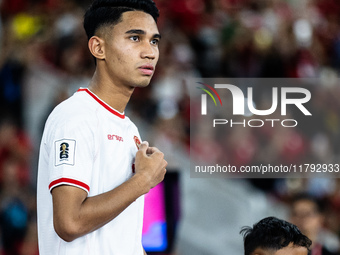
[135,142,168,190]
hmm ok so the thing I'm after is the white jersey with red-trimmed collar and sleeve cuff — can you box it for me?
[37,89,144,255]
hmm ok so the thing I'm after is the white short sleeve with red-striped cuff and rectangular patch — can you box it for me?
[46,117,95,193]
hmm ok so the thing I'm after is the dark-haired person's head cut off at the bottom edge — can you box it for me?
[240,217,312,255]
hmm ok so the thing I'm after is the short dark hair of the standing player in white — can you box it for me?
[84,0,159,39]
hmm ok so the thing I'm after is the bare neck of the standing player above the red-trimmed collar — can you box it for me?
[89,71,134,112]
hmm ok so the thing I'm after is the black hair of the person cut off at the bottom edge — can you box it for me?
[240,217,312,255]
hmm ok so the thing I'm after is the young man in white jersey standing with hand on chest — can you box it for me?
[37,0,167,255]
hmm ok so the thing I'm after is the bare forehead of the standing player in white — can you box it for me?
[113,11,159,35]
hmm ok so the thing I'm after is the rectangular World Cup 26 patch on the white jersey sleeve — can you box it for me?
[54,139,76,166]
